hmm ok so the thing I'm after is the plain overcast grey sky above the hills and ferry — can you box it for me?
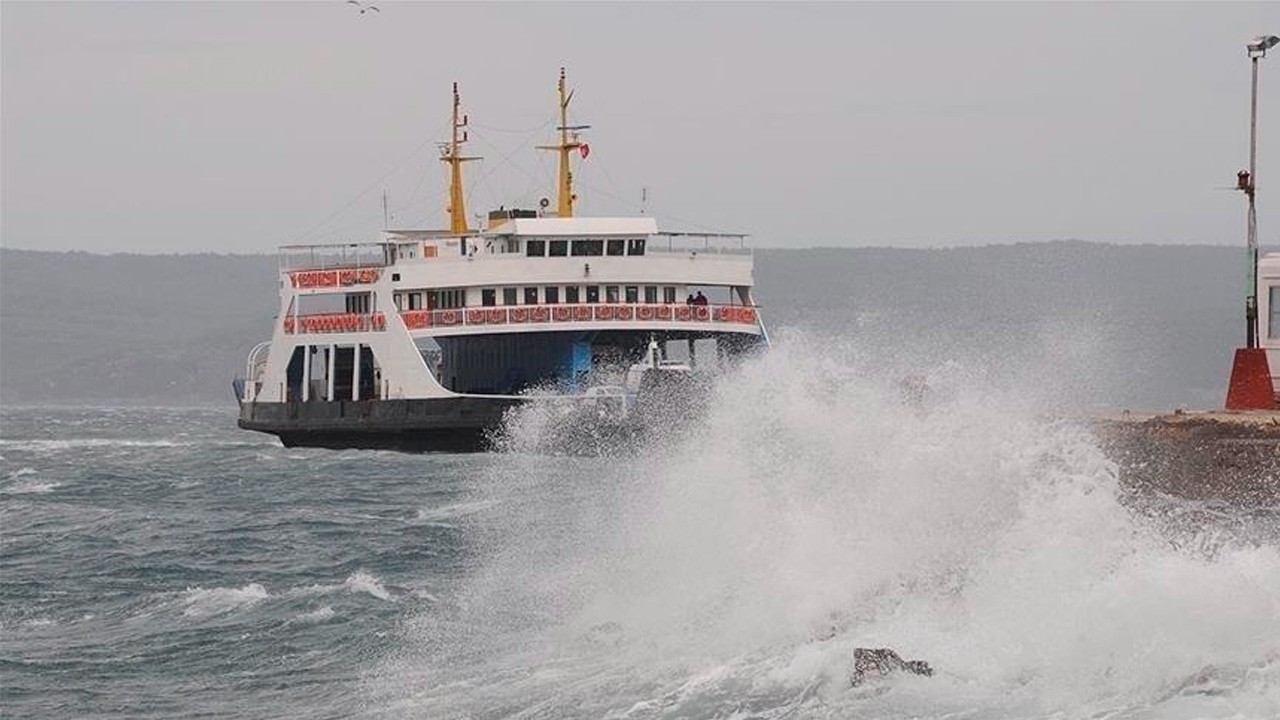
[0,0,1280,252]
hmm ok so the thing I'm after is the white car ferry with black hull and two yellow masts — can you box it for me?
[234,69,768,451]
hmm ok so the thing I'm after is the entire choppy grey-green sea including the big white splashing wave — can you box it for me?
[0,346,1280,719]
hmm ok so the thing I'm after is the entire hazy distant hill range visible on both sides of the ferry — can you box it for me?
[0,242,1244,407]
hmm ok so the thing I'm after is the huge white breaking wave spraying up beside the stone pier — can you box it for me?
[370,338,1280,717]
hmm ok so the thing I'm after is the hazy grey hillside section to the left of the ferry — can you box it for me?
[0,250,278,404]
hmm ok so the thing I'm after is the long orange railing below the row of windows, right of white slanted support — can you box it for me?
[401,302,759,331]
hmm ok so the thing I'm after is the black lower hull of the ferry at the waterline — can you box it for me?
[237,396,521,452]
